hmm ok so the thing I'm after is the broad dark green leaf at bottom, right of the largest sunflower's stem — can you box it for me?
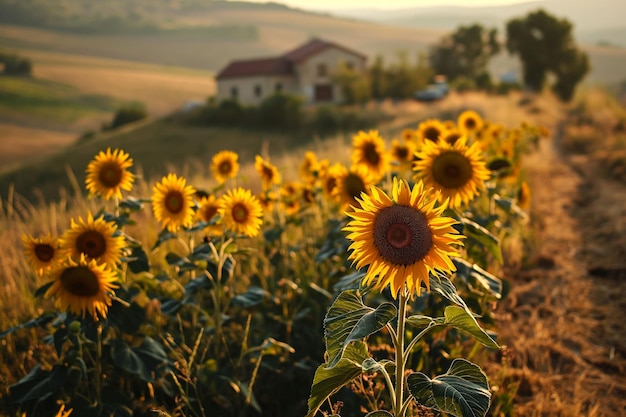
[407,359,491,417]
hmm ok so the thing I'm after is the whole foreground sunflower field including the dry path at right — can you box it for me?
[0,85,626,416]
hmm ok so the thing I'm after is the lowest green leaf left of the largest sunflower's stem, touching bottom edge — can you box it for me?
[306,342,369,417]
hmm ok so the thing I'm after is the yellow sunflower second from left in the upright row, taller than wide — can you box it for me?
[152,174,196,232]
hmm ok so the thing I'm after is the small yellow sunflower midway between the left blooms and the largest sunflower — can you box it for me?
[219,187,263,237]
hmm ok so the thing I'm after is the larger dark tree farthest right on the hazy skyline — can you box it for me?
[506,9,589,101]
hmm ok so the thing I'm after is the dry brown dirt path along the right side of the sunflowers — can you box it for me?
[492,116,626,417]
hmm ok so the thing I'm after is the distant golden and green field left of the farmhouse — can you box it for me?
[0,49,215,171]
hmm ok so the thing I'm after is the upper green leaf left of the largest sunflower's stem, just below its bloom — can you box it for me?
[324,290,396,368]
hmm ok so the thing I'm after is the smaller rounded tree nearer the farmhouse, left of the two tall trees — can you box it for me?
[429,24,500,80]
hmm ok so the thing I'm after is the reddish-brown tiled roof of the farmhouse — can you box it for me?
[216,39,365,80]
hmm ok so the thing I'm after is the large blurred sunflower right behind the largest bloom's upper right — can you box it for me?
[413,136,489,209]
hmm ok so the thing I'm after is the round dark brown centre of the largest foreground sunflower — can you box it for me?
[374,206,433,265]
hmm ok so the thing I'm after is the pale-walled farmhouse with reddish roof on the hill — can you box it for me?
[216,39,366,104]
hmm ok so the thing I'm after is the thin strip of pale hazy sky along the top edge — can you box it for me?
[239,0,528,10]
